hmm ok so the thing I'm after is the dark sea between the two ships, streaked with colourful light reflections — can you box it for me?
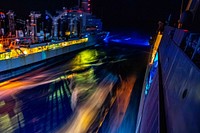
[0,31,149,133]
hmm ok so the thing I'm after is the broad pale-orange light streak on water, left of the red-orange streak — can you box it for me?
[60,75,117,133]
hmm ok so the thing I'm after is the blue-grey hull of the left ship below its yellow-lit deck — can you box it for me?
[0,37,96,82]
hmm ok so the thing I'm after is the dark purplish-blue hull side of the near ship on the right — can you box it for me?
[136,27,200,133]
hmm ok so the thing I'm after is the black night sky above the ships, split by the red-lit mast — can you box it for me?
[0,0,186,31]
